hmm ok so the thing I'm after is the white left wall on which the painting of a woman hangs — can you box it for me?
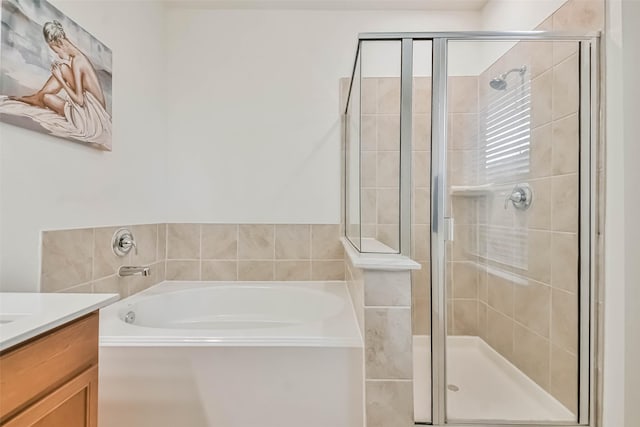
[0,0,166,291]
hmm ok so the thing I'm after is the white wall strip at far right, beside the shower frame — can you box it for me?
[603,0,640,427]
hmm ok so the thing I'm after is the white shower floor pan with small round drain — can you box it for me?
[413,335,575,422]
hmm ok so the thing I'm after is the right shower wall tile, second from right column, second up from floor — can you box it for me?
[514,280,551,338]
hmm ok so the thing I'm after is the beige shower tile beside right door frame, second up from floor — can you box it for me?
[551,289,578,354]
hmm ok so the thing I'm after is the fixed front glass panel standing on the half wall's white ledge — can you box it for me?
[360,41,401,253]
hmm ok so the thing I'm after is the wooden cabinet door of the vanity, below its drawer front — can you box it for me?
[3,366,98,427]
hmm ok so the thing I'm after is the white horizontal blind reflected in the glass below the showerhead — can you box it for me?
[480,71,531,184]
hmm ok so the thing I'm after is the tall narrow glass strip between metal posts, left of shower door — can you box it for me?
[411,41,432,422]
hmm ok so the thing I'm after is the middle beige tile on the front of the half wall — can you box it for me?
[364,307,413,379]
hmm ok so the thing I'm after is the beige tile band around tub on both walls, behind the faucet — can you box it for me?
[40,224,344,296]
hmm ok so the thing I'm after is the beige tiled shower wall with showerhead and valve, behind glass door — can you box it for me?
[442,0,604,412]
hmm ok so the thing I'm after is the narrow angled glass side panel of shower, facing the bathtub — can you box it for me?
[341,47,362,250]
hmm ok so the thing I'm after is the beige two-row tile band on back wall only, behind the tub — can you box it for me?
[166,224,344,281]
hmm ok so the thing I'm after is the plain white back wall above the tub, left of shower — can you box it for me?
[167,8,479,223]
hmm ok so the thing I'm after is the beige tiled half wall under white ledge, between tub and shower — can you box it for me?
[345,252,413,427]
